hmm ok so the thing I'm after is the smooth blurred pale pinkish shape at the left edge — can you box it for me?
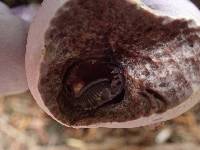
[0,2,28,96]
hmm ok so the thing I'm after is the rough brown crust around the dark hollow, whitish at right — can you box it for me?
[30,0,200,125]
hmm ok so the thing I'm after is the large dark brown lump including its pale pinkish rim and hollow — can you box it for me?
[26,0,200,128]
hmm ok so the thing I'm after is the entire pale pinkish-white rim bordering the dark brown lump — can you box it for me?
[26,0,200,128]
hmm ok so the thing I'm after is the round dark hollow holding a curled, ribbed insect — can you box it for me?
[65,60,124,111]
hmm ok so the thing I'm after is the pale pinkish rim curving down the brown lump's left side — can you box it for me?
[25,0,66,125]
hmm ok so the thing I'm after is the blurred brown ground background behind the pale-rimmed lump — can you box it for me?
[0,0,200,150]
